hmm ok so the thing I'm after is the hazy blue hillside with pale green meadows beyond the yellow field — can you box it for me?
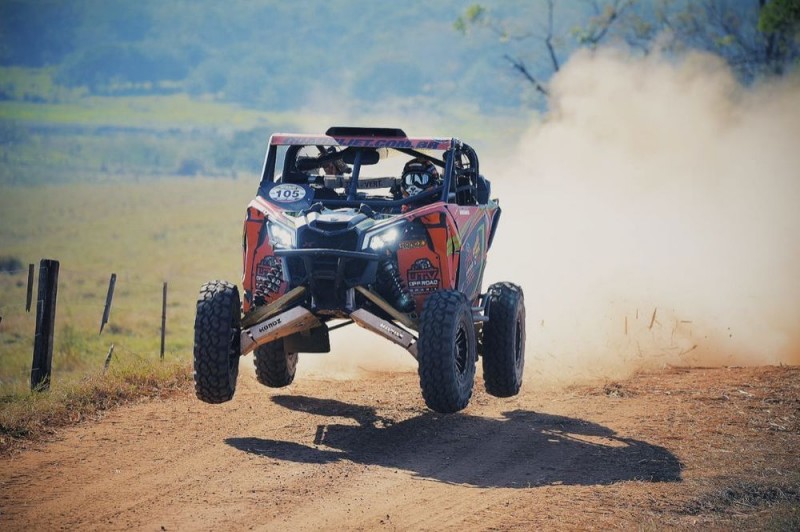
[0,0,552,184]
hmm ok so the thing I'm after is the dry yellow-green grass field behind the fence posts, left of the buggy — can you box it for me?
[0,177,256,395]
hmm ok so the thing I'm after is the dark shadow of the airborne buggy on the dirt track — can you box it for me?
[225,395,681,488]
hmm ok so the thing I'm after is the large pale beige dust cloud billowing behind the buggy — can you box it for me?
[482,50,800,383]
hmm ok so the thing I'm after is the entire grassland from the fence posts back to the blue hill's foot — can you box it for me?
[0,77,528,406]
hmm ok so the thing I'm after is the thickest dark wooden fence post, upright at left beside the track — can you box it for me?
[31,259,59,391]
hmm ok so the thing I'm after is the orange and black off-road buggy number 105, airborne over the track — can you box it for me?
[194,127,525,412]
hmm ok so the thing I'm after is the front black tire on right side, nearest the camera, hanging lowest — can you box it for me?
[417,290,477,414]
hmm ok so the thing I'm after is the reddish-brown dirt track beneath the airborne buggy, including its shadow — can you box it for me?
[0,359,800,530]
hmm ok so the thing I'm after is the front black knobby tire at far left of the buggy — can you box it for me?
[194,281,241,404]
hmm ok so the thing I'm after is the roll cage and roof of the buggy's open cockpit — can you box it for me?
[259,127,489,211]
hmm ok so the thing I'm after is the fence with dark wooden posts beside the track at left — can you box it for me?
[0,260,197,395]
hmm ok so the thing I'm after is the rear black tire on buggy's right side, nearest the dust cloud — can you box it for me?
[483,283,525,397]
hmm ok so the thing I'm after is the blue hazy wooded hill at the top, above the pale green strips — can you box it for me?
[0,0,536,110]
